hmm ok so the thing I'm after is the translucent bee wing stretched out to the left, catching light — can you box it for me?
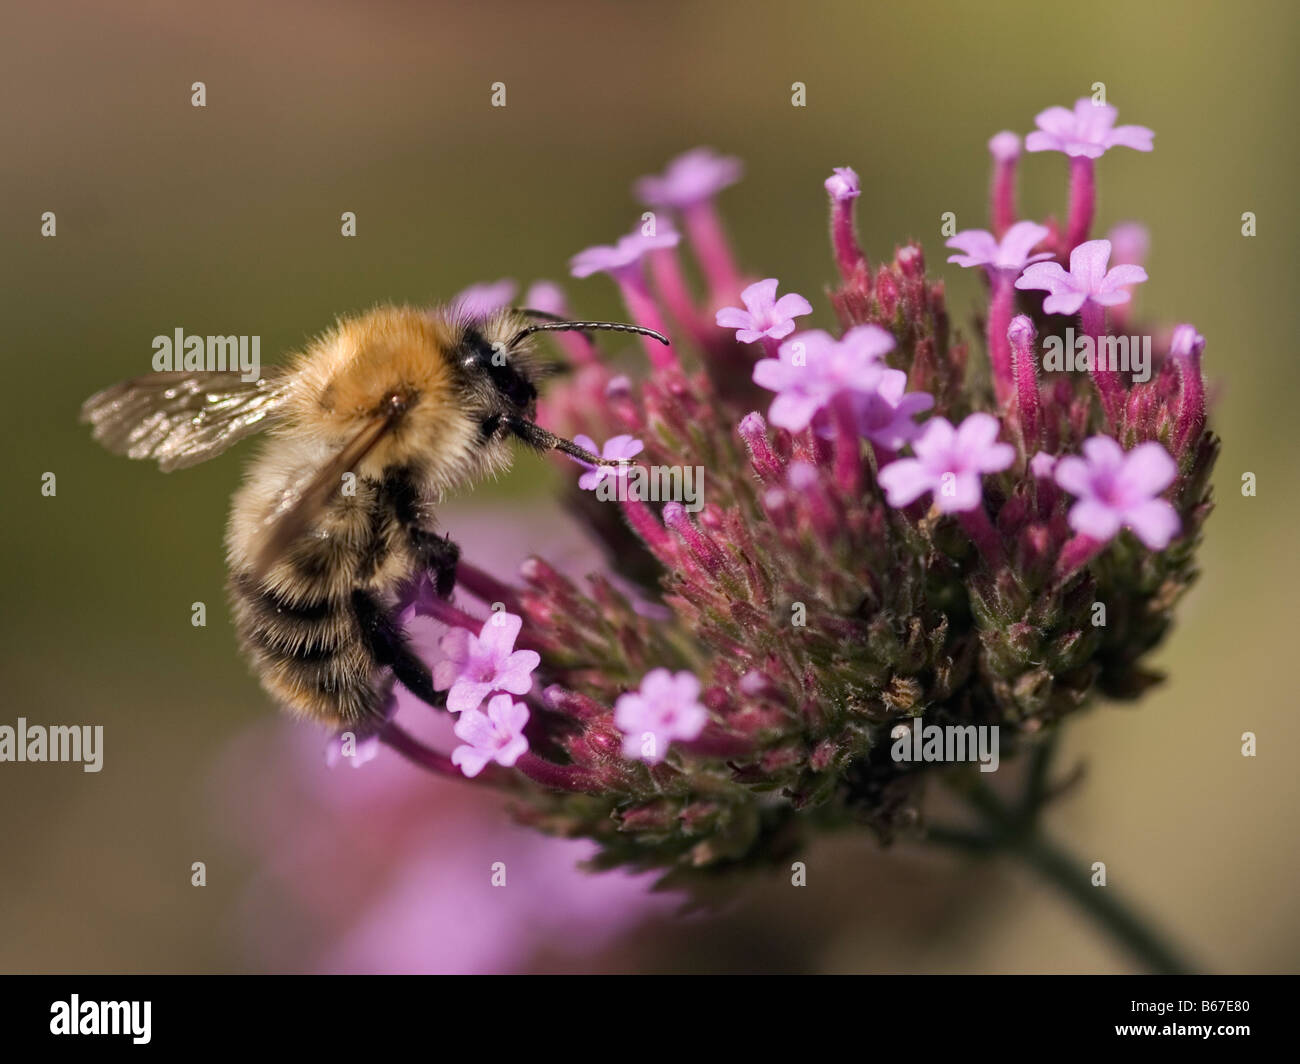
[81,372,287,472]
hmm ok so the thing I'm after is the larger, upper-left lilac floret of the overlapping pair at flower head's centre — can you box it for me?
[754,325,894,432]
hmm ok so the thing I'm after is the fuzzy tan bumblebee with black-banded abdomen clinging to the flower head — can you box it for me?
[82,306,668,730]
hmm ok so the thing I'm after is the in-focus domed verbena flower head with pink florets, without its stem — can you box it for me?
[369,100,1217,881]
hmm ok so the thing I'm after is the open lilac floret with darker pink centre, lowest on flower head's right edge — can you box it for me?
[1056,436,1179,550]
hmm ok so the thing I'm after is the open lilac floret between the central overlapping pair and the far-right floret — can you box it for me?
[880,414,1015,514]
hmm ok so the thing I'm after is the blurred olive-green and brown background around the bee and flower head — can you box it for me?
[0,0,1300,972]
